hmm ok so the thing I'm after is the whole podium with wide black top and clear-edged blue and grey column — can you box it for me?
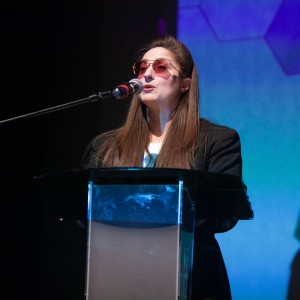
[35,168,253,300]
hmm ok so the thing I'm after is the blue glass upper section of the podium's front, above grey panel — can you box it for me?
[88,182,182,226]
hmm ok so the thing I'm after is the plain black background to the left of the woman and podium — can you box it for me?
[0,0,177,299]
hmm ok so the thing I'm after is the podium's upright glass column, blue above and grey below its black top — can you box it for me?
[86,180,193,300]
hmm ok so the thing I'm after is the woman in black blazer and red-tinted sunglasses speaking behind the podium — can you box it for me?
[85,36,242,299]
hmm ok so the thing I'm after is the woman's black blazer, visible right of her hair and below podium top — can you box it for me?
[192,120,246,300]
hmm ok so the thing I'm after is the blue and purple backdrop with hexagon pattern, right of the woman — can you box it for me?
[177,0,300,300]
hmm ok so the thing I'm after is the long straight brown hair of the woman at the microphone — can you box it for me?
[86,36,200,169]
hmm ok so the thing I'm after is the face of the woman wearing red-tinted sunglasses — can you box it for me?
[138,47,182,112]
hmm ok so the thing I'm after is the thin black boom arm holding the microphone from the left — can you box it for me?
[0,91,111,125]
